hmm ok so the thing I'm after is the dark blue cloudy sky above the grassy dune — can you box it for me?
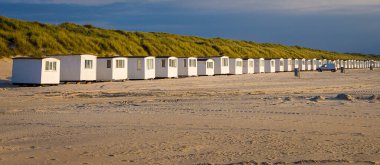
[0,0,380,54]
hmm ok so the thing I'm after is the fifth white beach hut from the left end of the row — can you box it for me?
[156,56,178,78]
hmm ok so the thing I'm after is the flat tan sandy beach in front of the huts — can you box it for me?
[0,60,380,164]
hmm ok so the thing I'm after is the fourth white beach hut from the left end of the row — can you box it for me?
[128,56,156,80]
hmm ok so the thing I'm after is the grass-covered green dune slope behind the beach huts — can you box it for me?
[0,16,379,59]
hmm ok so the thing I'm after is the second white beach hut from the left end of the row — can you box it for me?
[52,54,97,82]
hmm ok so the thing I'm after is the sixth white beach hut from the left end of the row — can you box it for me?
[178,57,198,77]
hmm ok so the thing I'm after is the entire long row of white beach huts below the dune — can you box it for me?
[12,54,380,85]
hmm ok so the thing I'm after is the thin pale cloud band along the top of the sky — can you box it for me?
[4,0,380,14]
